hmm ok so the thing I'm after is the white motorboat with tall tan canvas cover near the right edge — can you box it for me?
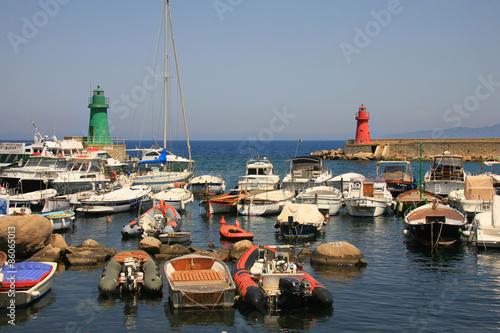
[448,176,496,218]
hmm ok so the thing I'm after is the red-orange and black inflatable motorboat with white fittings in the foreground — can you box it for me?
[233,245,333,310]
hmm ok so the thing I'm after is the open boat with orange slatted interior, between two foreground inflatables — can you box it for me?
[164,254,236,309]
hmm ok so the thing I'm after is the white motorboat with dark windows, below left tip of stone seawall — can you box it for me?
[281,155,332,192]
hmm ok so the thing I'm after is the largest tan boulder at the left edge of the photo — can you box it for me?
[0,215,54,260]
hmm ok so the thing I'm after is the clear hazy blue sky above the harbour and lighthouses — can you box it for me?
[0,0,500,141]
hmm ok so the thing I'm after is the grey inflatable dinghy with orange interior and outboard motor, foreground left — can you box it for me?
[97,250,163,294]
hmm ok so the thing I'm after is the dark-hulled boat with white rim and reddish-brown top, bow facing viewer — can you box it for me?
[404,200,467,247]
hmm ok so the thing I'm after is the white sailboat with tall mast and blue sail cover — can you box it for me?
[132,0,194,192]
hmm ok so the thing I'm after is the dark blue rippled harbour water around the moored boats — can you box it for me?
[0,141,500,332]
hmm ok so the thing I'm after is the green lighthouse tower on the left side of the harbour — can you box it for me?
[87,86,111,145]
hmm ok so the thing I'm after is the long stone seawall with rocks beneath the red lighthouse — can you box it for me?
[311,138,500,161]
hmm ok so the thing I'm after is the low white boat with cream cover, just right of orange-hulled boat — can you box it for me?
[237,189,295,216]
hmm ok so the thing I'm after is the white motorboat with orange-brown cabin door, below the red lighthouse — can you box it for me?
[343,177,392,216]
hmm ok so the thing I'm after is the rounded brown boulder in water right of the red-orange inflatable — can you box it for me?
[311,242,367,266]
